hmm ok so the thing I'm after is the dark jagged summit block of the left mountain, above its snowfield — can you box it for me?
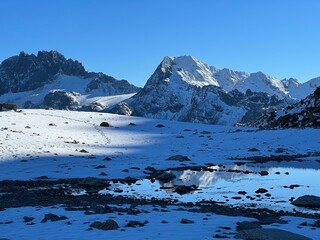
[0,51,87,95]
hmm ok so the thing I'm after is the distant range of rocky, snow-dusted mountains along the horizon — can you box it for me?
[0,51,320,124]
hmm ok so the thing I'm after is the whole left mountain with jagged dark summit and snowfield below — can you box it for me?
[0,51,140,110]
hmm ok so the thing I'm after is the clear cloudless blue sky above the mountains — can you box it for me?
[0,0,320,86]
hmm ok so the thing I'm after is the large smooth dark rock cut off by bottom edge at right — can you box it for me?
[235,228,311,240]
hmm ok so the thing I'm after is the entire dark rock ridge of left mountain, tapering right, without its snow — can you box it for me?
[0,51,140,95]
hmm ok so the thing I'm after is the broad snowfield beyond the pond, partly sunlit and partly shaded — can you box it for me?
[0,110,320,179]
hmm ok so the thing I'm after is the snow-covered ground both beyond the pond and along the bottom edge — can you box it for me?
[0,110,320,239]
